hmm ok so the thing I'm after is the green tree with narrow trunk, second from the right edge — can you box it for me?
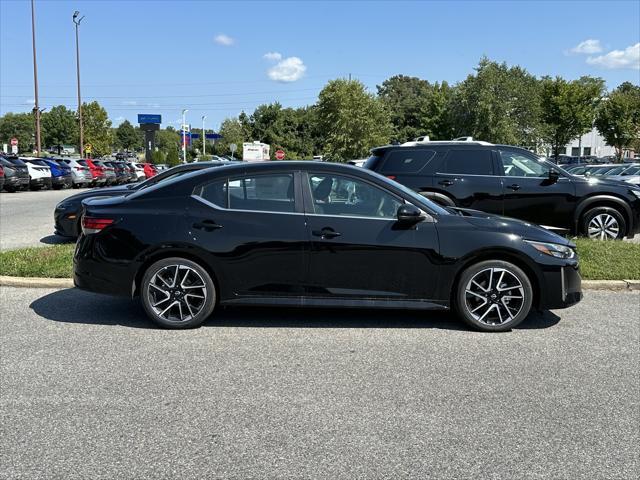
[540,77,604,159]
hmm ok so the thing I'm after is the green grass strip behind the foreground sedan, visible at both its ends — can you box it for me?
[0,238,640,280]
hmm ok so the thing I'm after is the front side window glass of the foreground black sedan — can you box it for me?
[309,173,403,219]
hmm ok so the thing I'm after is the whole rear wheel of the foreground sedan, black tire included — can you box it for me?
[140,257,217,329]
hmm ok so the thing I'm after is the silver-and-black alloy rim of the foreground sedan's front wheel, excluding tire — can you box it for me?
[465,268,525,325]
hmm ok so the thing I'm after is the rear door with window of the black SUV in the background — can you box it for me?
[433,146,503,214]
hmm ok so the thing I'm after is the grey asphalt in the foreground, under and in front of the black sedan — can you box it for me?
[0,288,640,479]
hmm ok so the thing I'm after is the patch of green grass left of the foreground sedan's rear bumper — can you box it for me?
[0,243,76,278]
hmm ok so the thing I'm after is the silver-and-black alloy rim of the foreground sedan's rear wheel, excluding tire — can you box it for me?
[147,264,207,323]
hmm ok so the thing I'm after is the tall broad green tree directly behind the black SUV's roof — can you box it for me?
[452,57,540,146]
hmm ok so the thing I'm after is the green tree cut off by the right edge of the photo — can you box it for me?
[595,82,640,160]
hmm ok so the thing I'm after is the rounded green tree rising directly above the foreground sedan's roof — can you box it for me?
[318,79,392,162]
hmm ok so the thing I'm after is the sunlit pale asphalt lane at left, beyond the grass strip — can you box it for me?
[0,189,91,250]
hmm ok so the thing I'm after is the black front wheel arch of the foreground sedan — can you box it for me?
[449,248,544,308]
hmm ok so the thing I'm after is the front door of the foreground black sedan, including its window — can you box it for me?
[302,172,438,300]
